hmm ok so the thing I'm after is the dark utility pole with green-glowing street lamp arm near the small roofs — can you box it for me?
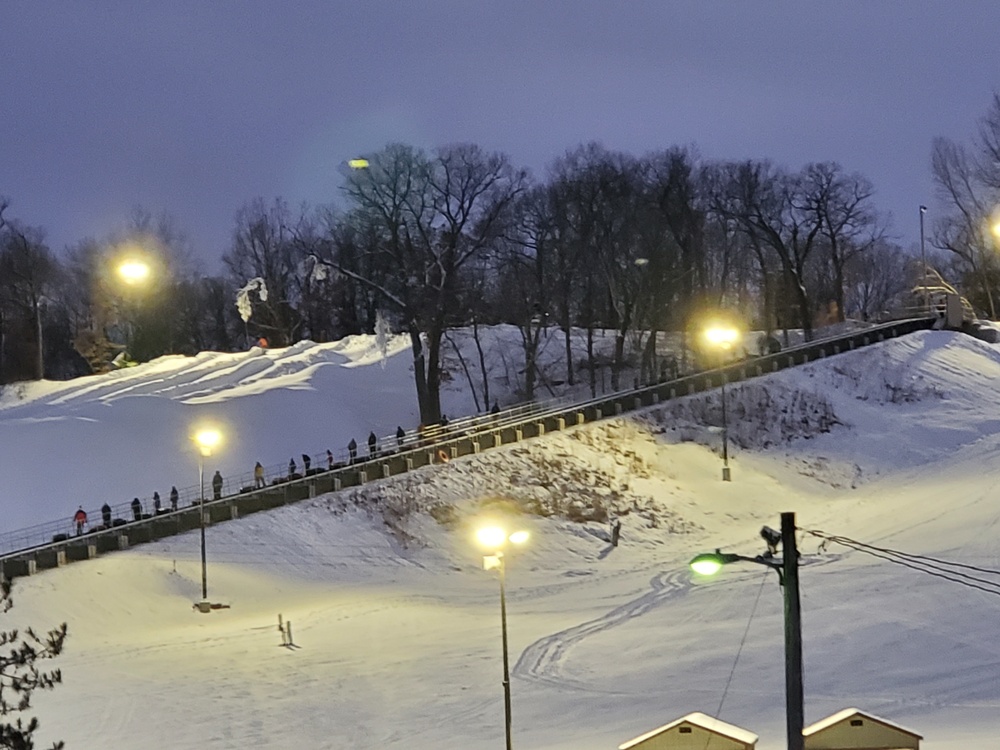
[690,513,805,750]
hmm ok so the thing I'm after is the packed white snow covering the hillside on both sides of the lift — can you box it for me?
[0,329,1000,750]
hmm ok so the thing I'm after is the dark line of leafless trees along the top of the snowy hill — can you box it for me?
[7,99,1000,423]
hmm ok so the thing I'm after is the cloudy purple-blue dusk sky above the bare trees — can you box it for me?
[0,0,1000,271]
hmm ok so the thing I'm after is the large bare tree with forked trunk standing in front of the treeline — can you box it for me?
[336,144,526,424]
